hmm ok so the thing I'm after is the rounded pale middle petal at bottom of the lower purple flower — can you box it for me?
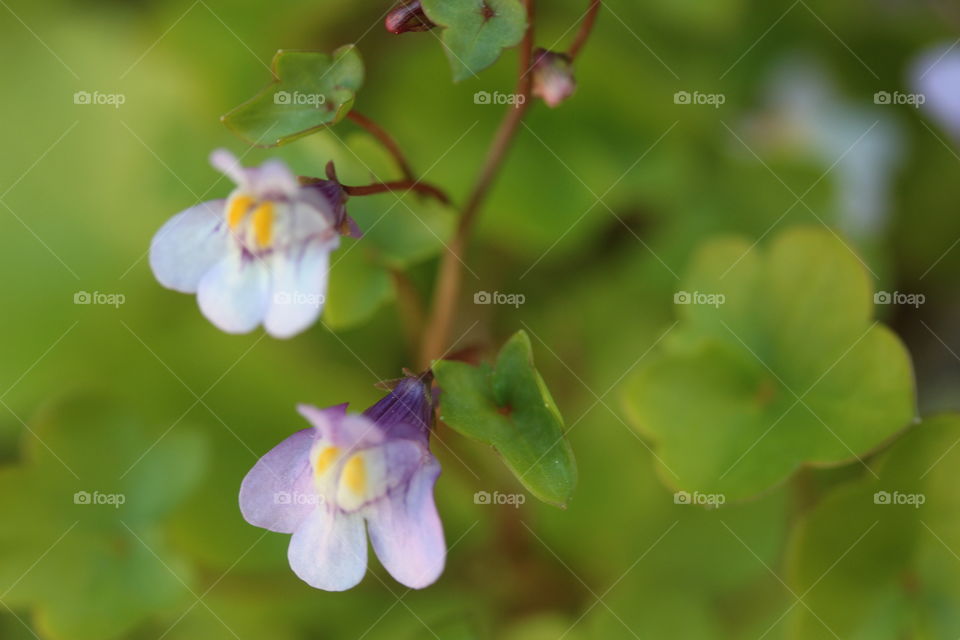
[287,506,367,591]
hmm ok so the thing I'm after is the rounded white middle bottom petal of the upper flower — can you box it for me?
[197,255,270,333]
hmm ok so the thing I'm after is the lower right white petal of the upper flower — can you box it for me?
[264,240,330,338]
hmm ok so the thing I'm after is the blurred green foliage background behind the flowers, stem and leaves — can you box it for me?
[0,0,960,640]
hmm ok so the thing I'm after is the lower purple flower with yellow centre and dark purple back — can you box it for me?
[240,377,446,591]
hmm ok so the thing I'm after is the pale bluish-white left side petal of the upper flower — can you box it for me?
[150,200,228,293]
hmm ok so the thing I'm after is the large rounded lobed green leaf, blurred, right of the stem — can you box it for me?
[625,228,914,501]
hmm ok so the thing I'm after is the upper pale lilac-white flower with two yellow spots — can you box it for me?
[150,149,350,338]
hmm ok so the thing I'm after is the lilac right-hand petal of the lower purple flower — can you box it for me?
[366,456,447,589]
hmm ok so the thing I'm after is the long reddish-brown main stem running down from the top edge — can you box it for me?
[420,0,534,368]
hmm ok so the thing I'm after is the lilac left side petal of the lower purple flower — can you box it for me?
[240,429,319,533]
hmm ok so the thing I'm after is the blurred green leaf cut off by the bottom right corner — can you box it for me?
[783,414,960,640]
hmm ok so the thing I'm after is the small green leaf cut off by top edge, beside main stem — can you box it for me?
[423,0,527,82]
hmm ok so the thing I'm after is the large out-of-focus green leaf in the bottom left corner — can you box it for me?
[0,396,204,640]
